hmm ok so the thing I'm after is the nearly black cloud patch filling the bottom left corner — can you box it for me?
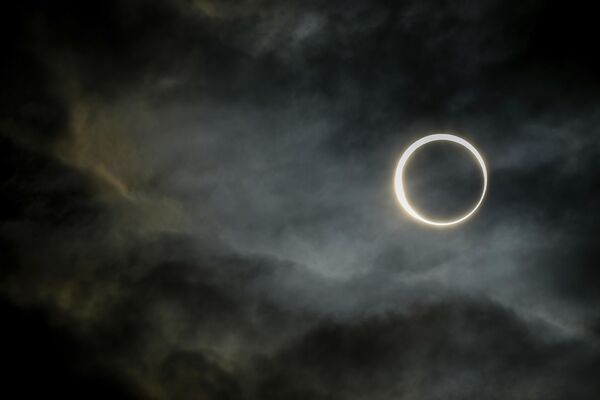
[0,301,138,399]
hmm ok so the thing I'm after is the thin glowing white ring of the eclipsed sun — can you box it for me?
[395,133,487,226]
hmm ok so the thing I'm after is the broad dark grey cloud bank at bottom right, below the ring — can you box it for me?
[261,300,598,399]
